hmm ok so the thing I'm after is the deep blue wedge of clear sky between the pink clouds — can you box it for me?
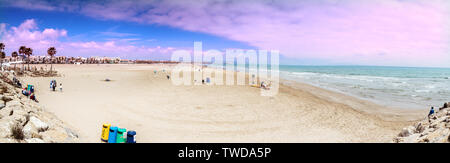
[0,7,255,53]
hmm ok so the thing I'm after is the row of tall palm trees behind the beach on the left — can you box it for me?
[0,42,56,72]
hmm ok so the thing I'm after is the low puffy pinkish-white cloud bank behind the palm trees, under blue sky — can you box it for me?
[0,19,179,59]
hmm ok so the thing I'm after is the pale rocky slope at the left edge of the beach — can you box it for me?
[0,73,78,143]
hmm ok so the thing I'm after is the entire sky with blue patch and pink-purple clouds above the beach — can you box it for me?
[0,0,450,67]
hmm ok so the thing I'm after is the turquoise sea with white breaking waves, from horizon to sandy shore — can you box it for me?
[279,65,450,109]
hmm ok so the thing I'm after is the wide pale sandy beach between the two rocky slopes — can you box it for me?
[21,64,427,143]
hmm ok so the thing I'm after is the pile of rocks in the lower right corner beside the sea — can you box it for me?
[393,102,450,143]
